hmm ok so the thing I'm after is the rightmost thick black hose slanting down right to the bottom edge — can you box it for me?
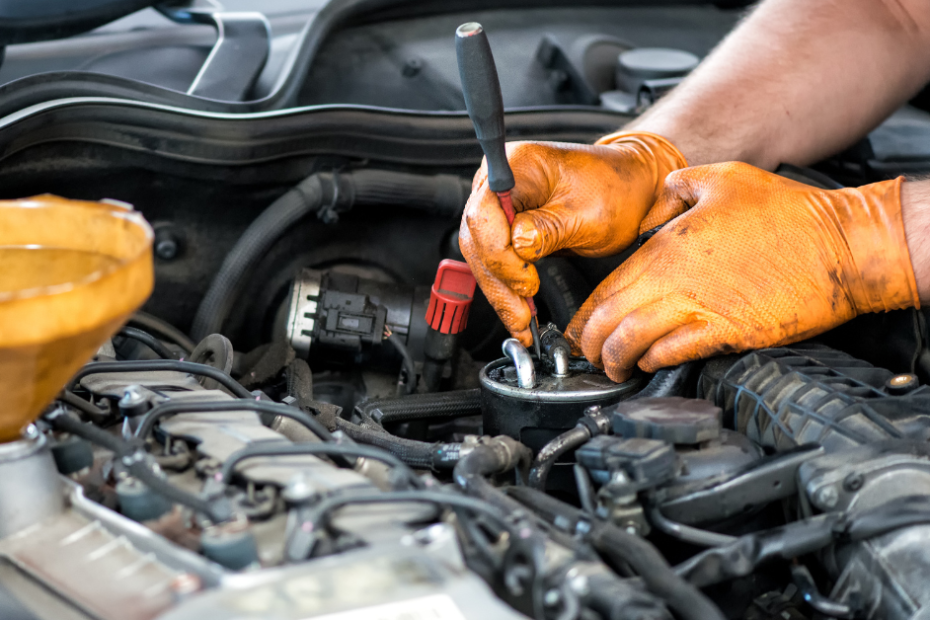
[507,487,724,620]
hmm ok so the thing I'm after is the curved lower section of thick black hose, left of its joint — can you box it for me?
[191,174,323,341]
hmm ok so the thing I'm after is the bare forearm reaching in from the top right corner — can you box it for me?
[628,0,930,169]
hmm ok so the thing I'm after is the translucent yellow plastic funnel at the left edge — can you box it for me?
[0,195,153,442]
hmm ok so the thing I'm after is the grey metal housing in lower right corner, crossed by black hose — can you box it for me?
[798,440,930,620]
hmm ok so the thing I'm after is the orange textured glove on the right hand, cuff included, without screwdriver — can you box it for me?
[566,163,920,381]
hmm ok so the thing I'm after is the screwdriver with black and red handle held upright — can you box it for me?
[455,22,541,359]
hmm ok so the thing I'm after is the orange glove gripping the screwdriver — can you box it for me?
[459,132,687,346]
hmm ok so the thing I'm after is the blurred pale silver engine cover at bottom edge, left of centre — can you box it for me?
[159,525,523,620]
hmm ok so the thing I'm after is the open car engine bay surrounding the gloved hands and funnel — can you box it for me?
[0,0,930,620]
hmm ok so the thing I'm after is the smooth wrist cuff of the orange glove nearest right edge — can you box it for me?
[834,177,920,314]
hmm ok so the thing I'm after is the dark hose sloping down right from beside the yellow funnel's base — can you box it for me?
[46,414,232,523]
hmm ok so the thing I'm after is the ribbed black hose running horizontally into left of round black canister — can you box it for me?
[358,389,481,425]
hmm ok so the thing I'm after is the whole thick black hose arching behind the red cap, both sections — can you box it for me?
[191,170,469,341]
